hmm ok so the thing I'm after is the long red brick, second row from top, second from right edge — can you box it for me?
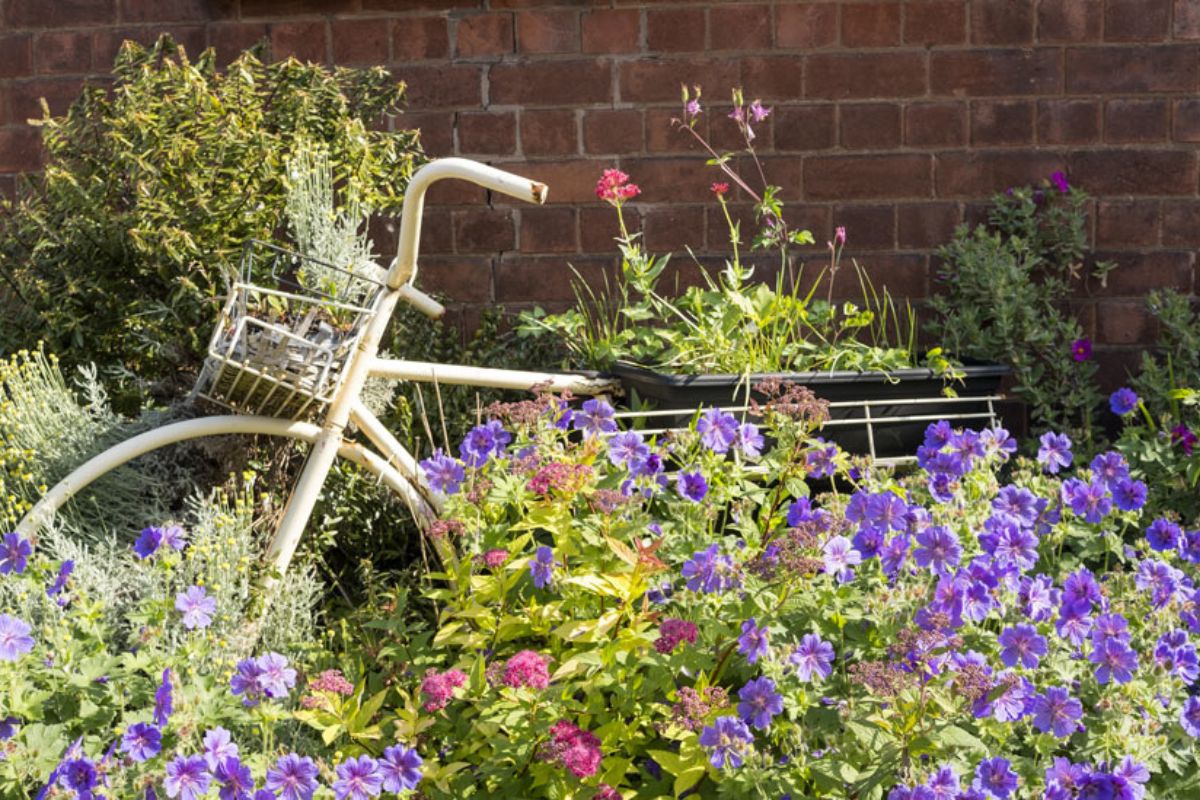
[929,50,1062,97]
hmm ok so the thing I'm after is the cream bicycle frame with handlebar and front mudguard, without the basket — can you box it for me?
[17,158,618,575]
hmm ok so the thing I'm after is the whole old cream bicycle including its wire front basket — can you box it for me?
[17,158,618,573]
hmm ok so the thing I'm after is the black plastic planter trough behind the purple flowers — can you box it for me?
[611,363,1009,463]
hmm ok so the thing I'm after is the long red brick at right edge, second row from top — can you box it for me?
[1066,46,1200,95]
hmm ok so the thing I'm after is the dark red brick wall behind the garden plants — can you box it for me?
[0,0,1200,381]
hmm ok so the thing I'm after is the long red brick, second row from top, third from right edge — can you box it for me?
[806,53,925,100]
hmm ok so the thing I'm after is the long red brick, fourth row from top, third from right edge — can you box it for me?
[804,156,932,200]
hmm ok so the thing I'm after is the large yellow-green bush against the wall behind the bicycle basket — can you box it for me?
[0,36,420,407]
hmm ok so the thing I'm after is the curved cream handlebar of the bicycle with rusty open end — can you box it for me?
[388,158,550,289]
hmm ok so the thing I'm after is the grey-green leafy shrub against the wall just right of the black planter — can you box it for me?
[929,181,1112,440]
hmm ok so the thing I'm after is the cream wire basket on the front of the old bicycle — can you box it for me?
[192,240,384,420]
